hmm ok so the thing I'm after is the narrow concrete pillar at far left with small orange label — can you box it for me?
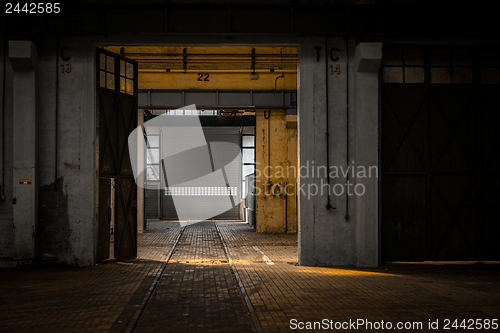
[9,41,38,264]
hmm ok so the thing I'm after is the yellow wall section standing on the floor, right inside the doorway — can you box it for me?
[255,110,298,233]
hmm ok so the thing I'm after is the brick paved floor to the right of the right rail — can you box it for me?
[218,223,500,332]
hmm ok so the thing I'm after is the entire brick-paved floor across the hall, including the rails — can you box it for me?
[0,221,500,333]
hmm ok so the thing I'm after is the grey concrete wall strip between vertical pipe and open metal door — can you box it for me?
[51,37,96,266]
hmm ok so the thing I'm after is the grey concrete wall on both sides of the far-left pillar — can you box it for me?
[0,37,96,266]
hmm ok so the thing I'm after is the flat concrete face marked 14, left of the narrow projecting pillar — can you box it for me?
[298,38,354,266]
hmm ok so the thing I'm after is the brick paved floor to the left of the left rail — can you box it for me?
[0,222,181,333]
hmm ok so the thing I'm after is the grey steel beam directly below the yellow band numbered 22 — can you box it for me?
[139,90,297,110]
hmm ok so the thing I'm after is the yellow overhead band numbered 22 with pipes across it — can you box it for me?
[105,46,297,91]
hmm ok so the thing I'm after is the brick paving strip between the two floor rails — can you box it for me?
[136,222,253,333]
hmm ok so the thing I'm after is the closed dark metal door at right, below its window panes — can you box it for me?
[382,85,481,261]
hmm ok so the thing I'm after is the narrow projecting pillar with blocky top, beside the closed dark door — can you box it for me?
[353,43,382,267]
